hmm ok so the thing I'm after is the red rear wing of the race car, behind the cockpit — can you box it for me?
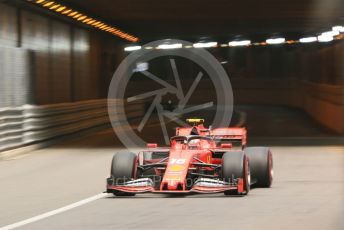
[209,128,247,146]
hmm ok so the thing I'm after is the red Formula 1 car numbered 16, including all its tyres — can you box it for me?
[107,119,273,196]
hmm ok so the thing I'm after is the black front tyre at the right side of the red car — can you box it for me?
[222,152,250,195]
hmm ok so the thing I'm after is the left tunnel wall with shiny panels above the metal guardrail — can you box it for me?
[0,3,123,106]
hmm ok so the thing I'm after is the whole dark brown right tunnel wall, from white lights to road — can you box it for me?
[219,40,344,134]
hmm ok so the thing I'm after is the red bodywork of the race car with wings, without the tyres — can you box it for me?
[107,124,246,193]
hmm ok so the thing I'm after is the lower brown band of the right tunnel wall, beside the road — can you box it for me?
[232,78,344,134]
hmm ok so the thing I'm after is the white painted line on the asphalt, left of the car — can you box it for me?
[0,193,108,230]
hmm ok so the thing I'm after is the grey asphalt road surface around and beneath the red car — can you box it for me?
[0,130,344,230]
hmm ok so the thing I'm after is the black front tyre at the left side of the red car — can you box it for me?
[111,152,136,196]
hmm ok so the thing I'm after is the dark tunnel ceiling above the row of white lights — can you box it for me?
[63,0,344,41]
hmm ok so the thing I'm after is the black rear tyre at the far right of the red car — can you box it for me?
[244,147,273,188]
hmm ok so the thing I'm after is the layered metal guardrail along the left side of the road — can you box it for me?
[0,99,144,152]
